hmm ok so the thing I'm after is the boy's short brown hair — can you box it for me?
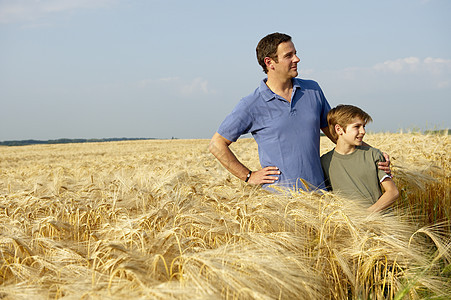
[327,104,373,139]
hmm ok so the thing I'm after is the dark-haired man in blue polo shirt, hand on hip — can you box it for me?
[209,33,389,189]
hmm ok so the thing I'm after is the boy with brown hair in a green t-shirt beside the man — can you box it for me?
[321,105,399,212]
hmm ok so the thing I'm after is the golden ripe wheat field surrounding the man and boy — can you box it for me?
[0,133,451,299]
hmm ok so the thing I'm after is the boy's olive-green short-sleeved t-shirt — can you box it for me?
[321,146,387,204]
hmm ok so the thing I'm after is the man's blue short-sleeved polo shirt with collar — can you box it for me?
[218,78,330,189]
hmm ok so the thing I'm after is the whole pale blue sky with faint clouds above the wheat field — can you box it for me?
[0,0,451,141]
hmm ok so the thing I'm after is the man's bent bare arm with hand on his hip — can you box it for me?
[208,132,280,184]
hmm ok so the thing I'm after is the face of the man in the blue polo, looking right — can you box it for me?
[271,41,300,79]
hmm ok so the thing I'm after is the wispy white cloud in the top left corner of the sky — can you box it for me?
[0,0,116,23]
